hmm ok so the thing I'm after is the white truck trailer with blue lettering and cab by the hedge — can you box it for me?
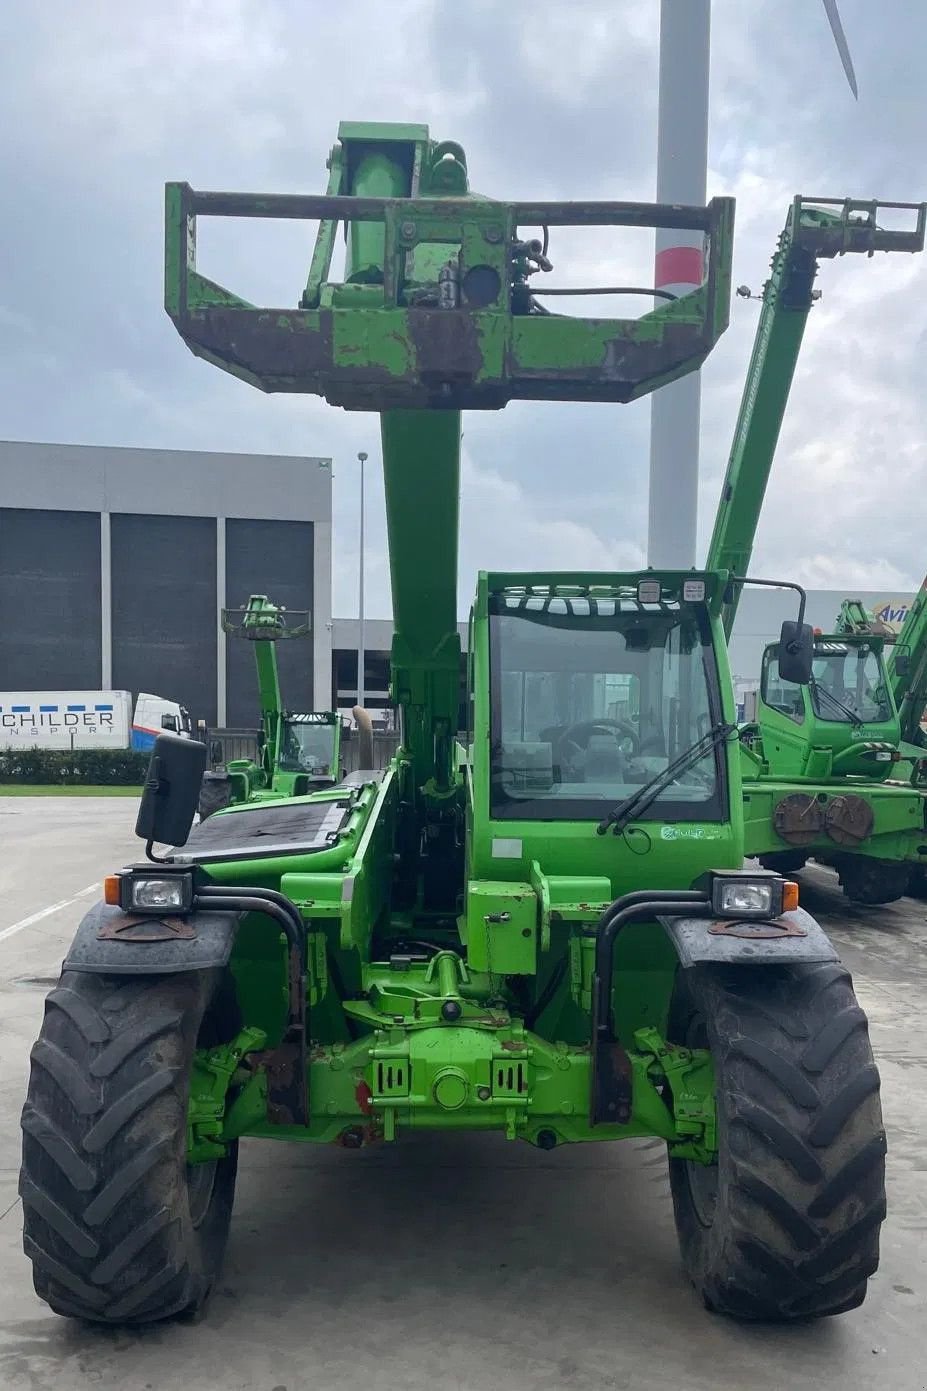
[0,691,192,750]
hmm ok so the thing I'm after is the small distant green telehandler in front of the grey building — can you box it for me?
[198,594,361,821]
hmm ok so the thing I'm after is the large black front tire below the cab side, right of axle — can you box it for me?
[670,963,885,1321]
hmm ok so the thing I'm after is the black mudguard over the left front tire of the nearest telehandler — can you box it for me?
[64,903,241,975]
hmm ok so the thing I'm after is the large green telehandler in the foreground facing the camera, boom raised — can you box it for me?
[21,122,885,1323]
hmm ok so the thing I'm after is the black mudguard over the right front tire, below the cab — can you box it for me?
[660,908,839,967]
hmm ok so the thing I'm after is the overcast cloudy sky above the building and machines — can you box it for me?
[0,0,927,615]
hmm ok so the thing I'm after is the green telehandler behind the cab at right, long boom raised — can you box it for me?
[706,198,927,903]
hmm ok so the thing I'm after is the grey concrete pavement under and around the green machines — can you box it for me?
[0,797,927,1391]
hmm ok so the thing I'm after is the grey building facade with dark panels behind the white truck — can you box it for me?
[0,441,331,726]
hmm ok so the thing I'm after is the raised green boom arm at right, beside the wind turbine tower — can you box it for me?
[706,198,927,636]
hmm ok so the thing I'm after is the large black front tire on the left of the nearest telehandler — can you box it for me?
[19,971,238,1324]
